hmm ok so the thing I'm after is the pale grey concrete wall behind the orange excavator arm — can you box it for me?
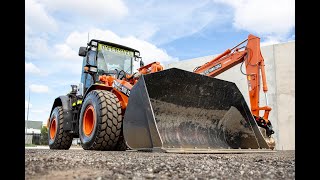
[165,41,295,150]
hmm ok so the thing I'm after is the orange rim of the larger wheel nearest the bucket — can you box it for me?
[83,105,95,137]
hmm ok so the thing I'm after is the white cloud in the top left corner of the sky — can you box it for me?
[25,0,58,32]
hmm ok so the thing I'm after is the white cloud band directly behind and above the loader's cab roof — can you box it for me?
[56,28,178,72]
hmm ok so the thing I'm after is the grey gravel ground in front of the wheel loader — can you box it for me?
[25,149,295,180]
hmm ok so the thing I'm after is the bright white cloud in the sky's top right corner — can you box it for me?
[216,0,295,39]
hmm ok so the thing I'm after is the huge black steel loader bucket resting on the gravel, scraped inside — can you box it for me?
[123,68,271,153]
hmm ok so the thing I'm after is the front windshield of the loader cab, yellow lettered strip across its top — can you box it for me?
[97,44,134,75]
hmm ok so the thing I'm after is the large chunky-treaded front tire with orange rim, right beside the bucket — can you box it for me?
[79,90,123,151]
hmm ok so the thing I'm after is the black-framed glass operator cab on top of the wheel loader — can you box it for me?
[79,39,141,95]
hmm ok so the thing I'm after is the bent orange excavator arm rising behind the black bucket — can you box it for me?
[194,34,274,137]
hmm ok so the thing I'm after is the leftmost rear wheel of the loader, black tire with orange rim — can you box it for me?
[48,106,73,149]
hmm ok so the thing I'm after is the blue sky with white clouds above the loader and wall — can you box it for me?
[25,0,295,122]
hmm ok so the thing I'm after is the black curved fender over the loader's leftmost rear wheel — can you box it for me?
[47,96,72,131]
